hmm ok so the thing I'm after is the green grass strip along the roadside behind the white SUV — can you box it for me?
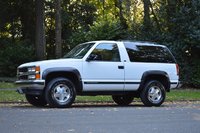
[0,82,200,102]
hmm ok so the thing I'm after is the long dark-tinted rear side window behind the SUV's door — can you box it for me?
[124,43,175,63]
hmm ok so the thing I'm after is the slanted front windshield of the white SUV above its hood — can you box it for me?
[64,43,94,59]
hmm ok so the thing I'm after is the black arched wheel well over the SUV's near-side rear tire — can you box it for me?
[142,74,170,92]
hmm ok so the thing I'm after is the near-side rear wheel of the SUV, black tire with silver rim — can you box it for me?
[140,80,166,106]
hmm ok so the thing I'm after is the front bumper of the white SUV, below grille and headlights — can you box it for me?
[15,80,45,95]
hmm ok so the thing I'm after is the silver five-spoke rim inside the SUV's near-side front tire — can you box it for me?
[52,84,71,104]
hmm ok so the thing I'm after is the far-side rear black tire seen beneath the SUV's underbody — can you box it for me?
[112,95,134,106]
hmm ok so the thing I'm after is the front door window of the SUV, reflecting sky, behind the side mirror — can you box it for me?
[90,43,120,62]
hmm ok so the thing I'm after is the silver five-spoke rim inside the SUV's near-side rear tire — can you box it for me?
[148,86,162,103]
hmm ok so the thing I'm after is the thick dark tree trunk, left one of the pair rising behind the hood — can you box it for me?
[35,0,46,60]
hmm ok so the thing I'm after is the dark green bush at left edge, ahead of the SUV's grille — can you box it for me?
[0,40,35,77]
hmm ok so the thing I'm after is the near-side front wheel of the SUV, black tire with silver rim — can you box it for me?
[45,77,76,108]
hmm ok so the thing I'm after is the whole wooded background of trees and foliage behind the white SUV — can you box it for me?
[0,0,200,88]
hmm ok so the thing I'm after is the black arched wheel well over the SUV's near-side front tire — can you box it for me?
[45,71,82,93]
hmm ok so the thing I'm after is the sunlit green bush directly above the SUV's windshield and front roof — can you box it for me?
[68,20,127,47]
